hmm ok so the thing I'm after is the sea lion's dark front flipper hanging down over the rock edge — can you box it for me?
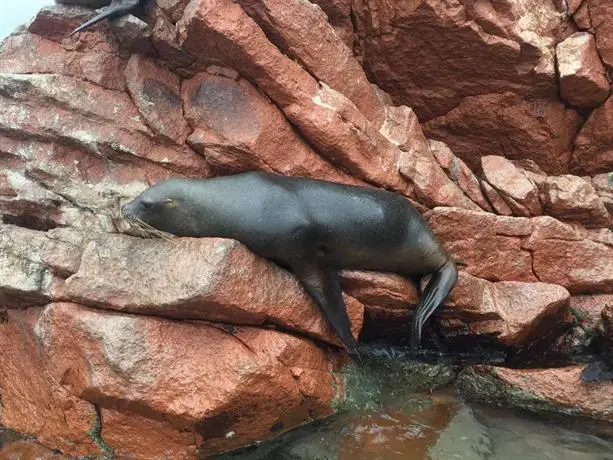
[292,262,359,357]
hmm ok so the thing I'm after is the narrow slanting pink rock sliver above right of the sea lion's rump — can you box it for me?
[428,140,493,212]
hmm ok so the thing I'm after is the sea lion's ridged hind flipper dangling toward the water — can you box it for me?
[411,259,458,352]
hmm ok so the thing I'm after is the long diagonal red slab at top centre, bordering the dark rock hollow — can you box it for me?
[238,0,385,128]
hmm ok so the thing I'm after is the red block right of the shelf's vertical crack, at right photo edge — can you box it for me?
[532,239,613,294]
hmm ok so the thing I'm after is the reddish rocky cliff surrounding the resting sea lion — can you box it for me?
[0,0,613,458]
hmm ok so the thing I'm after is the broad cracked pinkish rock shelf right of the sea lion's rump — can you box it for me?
[427,208,613,293]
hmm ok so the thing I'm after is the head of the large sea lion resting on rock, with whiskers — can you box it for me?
[121,179,195,237]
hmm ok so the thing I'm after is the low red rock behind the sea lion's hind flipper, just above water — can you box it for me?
[342,272,571,349]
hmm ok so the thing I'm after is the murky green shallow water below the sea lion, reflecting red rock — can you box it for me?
[0,347,613,460]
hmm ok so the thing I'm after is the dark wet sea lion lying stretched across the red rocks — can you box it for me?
[122,172,458,354]
